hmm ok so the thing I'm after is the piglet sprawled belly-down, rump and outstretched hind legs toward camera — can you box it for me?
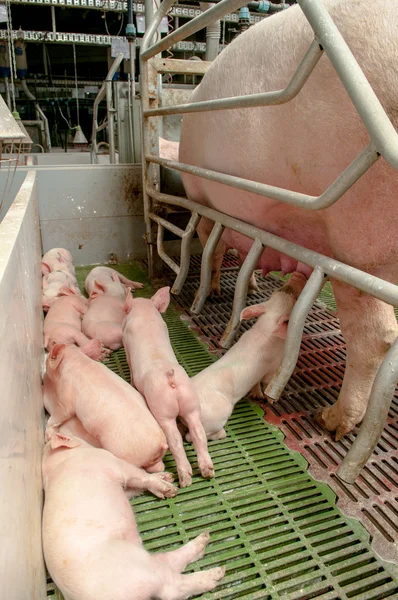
[123,287,214,487]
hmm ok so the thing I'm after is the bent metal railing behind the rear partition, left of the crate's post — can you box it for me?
[91,52,123,165]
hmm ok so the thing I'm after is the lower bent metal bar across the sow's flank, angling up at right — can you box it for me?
[145,145,379,210]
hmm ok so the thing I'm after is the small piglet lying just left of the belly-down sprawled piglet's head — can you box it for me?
[82,283,131,350]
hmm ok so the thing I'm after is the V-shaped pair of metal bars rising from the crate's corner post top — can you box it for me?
[141,0,247,60]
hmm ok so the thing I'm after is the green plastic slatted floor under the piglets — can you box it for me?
[48,266,398,600]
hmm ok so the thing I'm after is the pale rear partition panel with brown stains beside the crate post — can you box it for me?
[0,165,146,265]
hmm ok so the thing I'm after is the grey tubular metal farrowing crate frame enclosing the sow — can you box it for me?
[141,0,398,483]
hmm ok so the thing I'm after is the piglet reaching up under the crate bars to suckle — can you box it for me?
[186,272,306,441]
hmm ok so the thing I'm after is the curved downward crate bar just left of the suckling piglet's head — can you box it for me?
[220,238,264,348]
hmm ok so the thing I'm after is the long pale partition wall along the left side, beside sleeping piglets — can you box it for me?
[0,172,46,600]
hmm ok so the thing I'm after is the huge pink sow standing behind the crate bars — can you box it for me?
[179,0,398,439]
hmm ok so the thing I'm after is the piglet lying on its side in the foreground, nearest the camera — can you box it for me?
[42,431,225,600]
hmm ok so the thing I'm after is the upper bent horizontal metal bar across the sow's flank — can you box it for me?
[143,39,323,117]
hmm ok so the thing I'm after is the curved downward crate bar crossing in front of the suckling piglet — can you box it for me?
[265,267,326,404]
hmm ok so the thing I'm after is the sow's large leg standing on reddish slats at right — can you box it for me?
[317,281,398,440]
